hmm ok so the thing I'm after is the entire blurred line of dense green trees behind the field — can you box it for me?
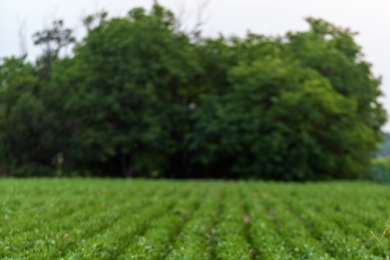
[0,3,387,181]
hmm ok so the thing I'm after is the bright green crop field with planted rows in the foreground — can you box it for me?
[0,179,390,260]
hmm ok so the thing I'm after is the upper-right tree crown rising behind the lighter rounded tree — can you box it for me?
[286,18,387,134]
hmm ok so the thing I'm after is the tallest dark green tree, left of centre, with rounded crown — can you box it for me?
[56,4,200,176]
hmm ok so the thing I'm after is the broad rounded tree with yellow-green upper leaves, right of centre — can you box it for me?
[189,58,373,180]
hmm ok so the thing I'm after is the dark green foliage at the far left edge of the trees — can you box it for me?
[0,58,57,173]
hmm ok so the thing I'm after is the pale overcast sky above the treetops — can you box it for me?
[0,0,390,131]
